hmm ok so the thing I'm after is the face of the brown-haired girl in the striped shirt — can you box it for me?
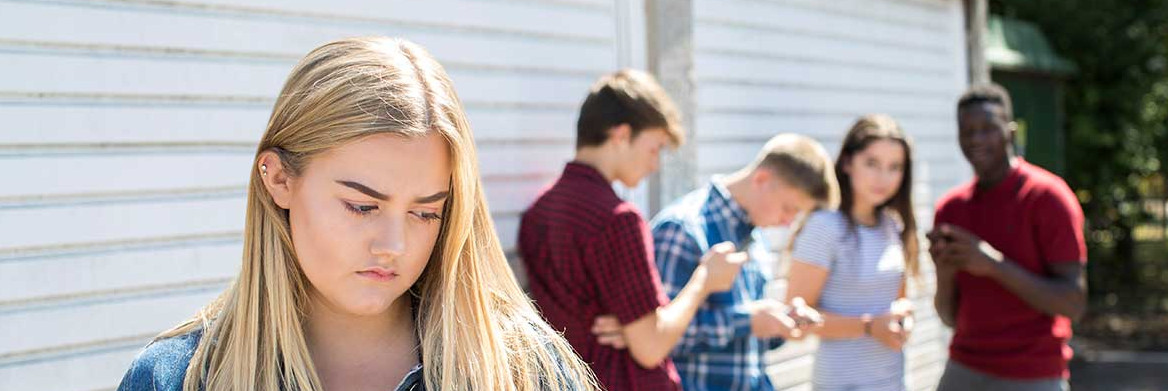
[843,139,905,214]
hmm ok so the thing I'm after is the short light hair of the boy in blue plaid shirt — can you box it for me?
[750,133,840,208]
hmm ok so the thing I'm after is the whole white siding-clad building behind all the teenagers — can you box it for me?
[0,0,969,391]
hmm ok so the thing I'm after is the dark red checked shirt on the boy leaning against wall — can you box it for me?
[519,162,680,391]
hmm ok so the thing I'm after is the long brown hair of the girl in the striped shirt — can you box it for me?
[835,114,920,275]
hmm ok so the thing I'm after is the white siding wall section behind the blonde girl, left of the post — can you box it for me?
[0,0,644,390]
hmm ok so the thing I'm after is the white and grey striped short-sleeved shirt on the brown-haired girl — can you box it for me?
[791,211,904,391]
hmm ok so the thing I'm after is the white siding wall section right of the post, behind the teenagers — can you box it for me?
[694,0,969,390]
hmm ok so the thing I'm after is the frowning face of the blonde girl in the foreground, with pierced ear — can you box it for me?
[260,133,451,315]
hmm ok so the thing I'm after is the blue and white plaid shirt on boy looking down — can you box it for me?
[651,181,783,391]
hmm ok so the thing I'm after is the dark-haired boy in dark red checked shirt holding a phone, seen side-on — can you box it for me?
[519,70,746,391]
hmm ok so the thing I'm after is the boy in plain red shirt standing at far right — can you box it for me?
[929,85,1086,391]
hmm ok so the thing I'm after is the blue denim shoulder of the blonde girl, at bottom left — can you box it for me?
[118,329,202,391]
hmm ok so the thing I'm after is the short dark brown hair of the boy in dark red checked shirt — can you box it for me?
[576,69,686,149]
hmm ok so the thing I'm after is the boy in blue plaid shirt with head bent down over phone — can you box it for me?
[595,134,839,391]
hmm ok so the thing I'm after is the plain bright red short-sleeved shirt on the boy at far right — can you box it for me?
[933,159,1086,379]
